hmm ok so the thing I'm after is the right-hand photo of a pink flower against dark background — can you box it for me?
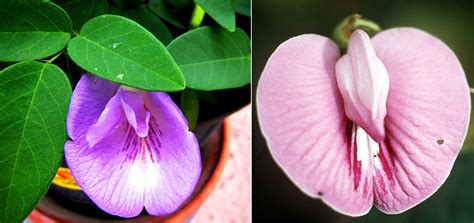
[252,0,474,223]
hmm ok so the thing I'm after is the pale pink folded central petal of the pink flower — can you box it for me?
[336,30,389,142]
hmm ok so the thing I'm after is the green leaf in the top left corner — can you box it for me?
[0,1,71,61]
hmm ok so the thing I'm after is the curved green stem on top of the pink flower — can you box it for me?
[333,14,381,49]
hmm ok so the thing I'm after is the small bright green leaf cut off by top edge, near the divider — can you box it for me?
[196,0,235,32]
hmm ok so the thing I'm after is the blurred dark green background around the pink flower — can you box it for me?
[252,0,474,223]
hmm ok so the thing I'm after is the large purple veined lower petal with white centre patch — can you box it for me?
[65,89,201,217]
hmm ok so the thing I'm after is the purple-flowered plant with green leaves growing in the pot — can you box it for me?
[0,0,250,222]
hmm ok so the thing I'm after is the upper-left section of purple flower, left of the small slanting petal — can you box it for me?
[67,73,119,140]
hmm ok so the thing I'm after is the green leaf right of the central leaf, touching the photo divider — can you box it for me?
[167,27,250,91]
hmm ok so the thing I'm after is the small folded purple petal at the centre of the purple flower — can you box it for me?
[121,91,150,137]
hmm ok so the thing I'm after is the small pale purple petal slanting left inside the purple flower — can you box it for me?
[86,93,124,148]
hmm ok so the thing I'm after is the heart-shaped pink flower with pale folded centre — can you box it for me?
[257,28,470,216]
